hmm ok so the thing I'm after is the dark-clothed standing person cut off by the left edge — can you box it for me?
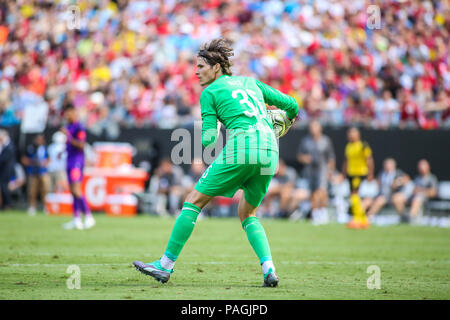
[0,130,16,210]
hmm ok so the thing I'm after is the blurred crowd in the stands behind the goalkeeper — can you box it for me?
[0,0,450,132]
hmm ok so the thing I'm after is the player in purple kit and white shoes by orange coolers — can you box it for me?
[61,103,95,230]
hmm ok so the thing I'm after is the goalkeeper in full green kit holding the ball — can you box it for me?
[133,39,298,287]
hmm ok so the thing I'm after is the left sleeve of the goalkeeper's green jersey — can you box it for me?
[200,90,218,147]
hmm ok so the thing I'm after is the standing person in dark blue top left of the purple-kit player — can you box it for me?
[22,134,50,216]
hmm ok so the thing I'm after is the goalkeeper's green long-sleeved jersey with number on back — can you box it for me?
[200,75,298,151]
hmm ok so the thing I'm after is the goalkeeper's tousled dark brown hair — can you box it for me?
[198,38,234,76]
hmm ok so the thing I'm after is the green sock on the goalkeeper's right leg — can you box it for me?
[242,217,272,264]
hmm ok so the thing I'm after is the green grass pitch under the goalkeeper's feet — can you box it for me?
[0,212,450,299]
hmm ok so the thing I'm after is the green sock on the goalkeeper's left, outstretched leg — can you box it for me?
[164,202,201,261]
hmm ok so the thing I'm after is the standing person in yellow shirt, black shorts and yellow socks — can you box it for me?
[342,127,374,229]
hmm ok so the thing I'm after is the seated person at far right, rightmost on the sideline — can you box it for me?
[392,159,438,223]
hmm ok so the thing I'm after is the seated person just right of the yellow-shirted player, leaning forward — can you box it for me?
[367,158,412,219]
